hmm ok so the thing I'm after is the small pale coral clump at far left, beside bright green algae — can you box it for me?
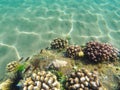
[6,61,19,72]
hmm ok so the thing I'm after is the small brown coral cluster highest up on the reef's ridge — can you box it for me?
[51,38,68,49]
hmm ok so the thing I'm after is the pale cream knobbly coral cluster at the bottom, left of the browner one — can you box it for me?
[23,71,60,90]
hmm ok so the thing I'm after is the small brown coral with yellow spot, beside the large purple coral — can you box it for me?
[66,45,84,59]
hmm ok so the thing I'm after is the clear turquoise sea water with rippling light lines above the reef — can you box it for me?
[0,0,120,79]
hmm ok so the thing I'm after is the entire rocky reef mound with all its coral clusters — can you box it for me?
[0,38,120,90]
